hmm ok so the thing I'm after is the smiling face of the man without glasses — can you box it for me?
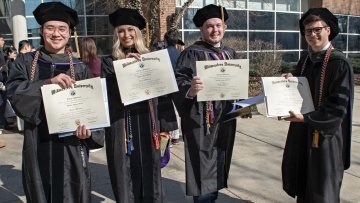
[200,18,225,47]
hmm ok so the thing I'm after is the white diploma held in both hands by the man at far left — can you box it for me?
[41,77,110,134]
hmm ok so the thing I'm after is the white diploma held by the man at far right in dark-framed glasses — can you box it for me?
[261,77,315,117]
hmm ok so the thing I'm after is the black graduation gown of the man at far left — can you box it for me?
[7,50,104,203]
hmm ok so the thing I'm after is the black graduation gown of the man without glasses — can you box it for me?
[174,41,236,196]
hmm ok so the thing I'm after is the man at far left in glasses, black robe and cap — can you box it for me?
[7,2,104,203]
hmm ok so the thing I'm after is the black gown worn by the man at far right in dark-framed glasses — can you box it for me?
[282,49,354,203]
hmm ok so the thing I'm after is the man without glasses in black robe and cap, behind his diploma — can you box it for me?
[174,5,242,202]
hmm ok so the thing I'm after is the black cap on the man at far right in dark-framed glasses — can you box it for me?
[299,8,339,41]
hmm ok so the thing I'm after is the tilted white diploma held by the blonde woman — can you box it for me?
[113,49,179,105]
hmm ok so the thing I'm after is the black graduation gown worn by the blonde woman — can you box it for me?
[101,52,177,203]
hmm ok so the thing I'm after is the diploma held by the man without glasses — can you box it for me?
[196,59,249,101]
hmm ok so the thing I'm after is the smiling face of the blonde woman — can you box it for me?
[117,25,136,48]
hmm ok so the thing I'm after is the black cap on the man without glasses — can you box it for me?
[193,4,229,27]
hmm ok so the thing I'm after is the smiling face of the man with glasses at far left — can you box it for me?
[41,21,70,54]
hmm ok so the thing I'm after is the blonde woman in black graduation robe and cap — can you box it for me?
[101,8,177,203]
